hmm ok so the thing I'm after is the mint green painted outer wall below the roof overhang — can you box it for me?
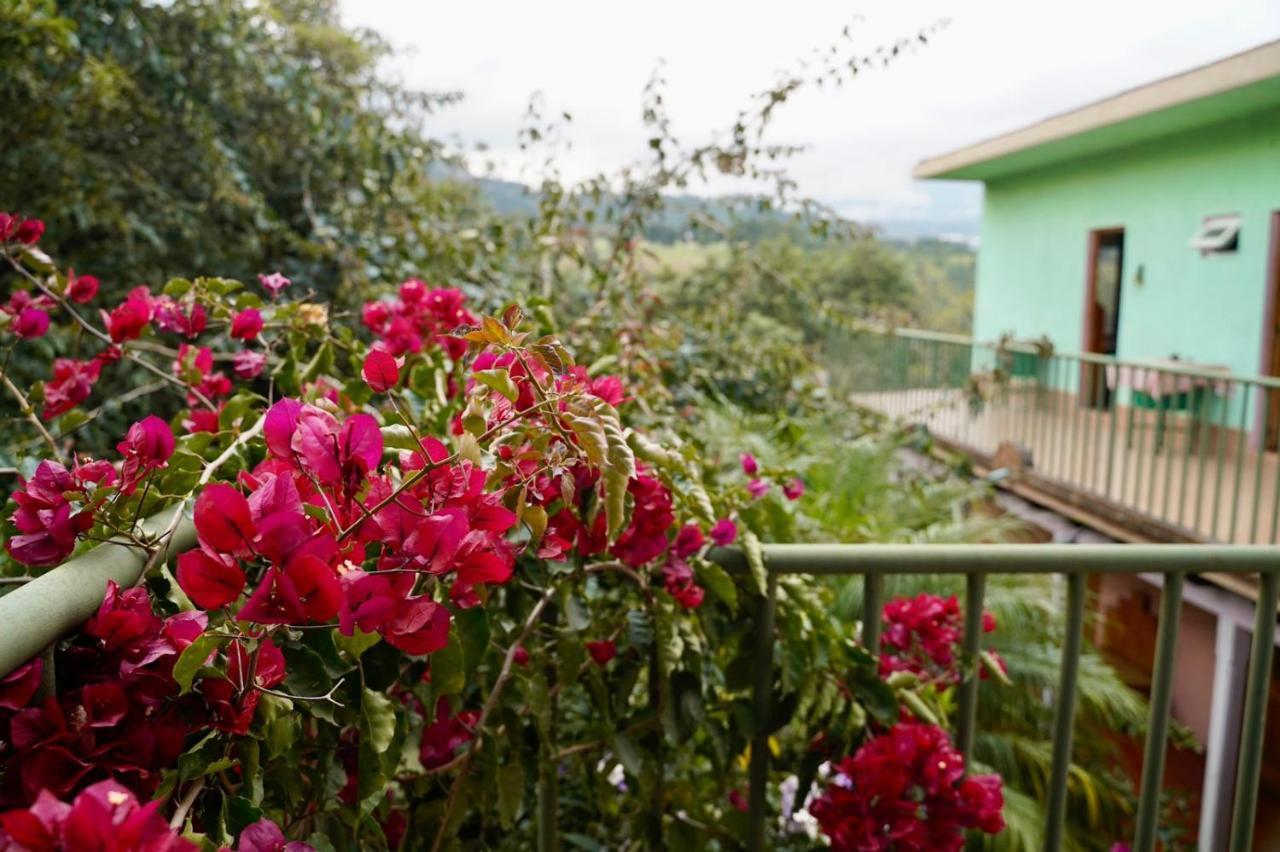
[974,109,1280,383]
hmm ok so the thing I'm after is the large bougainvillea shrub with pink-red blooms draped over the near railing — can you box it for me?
[0,216,998,851]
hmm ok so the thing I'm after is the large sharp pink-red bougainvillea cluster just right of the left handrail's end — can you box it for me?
[178,399,516,655]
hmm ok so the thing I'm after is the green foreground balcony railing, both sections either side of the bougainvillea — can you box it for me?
[0,509,1280,852]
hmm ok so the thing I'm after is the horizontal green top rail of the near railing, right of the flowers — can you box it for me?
[710,544,1280,574]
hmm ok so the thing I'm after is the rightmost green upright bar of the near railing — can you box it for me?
[1230,562,1280,852]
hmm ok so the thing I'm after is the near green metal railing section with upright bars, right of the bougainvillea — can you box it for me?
[714,544,1280,852]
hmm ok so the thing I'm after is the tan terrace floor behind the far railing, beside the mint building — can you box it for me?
[852,389,1280,544]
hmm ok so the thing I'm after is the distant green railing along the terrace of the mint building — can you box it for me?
[827,327,1280,544]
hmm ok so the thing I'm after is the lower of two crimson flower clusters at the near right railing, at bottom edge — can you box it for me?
[809,723,1005,852]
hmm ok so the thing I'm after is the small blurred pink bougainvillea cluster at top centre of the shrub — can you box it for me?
[364,278,476,361]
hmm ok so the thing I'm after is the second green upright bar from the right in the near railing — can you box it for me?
[1133,573,1182,852]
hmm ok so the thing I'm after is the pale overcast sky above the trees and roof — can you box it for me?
[340,0,1280,227]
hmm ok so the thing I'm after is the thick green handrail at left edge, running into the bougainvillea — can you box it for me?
[0,504,196,678]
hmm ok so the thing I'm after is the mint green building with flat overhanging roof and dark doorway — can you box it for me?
[914,41,1280,399]
